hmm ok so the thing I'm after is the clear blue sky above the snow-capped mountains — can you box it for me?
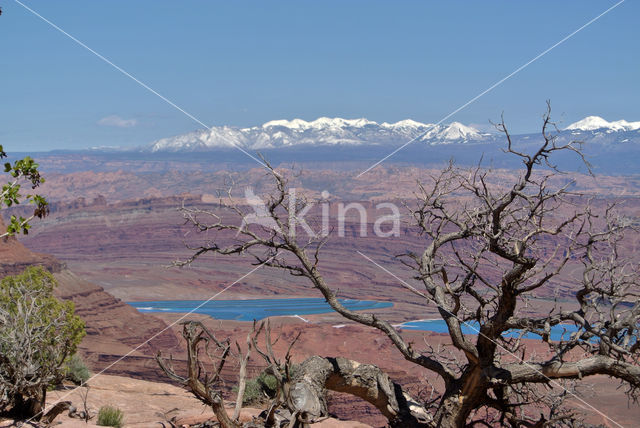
[0,0,640,151]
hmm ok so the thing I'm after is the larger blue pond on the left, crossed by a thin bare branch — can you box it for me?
[128,298,393,321]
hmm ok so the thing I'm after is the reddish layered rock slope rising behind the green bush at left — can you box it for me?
[0,221,179,380]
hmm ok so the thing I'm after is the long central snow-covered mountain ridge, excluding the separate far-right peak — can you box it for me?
[149,117,487,152]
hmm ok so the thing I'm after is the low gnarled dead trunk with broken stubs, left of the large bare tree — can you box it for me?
[156,321,429,428]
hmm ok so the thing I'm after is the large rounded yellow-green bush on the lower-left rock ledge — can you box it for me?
[0,267,85,419]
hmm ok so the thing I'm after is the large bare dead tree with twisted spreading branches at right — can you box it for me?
[176,104,640,427]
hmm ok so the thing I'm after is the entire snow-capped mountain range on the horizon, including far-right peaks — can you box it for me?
[146,116,640,152]
